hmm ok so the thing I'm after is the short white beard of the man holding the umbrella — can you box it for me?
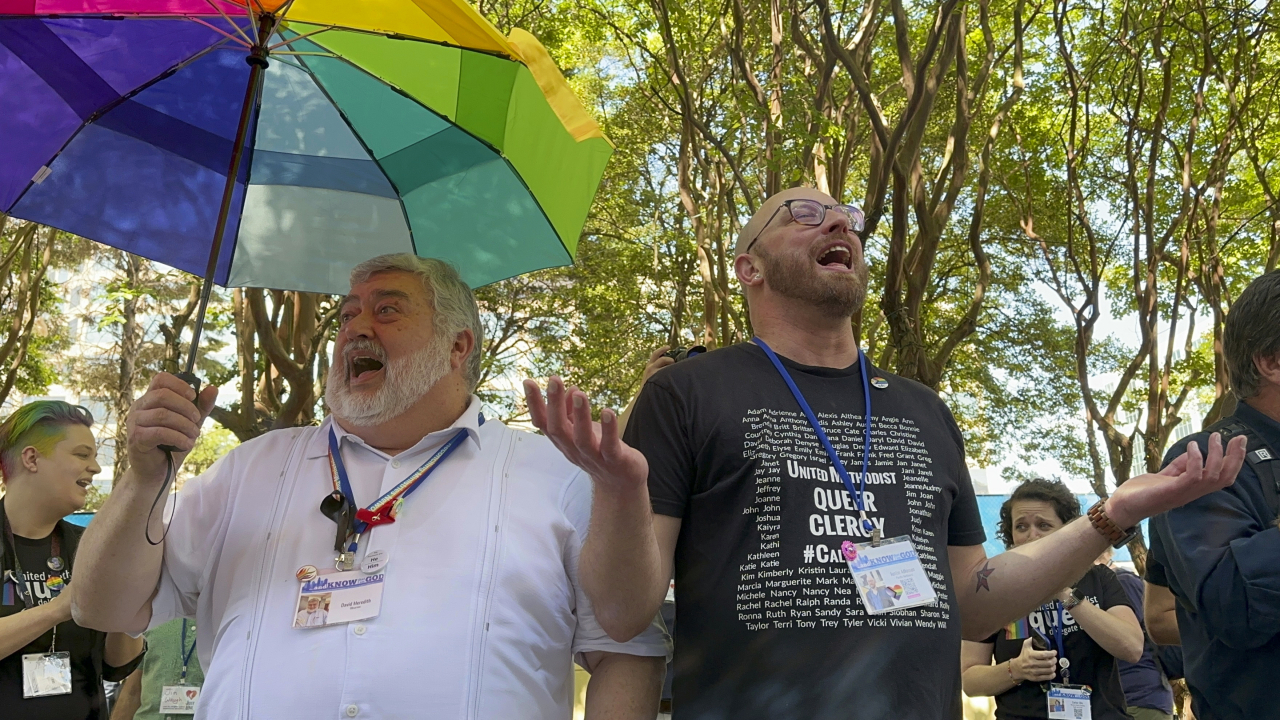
[325,336,453,428]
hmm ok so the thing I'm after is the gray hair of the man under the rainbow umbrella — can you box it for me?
[351,252,484,391]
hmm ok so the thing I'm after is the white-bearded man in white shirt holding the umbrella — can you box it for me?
[72,255,667,720]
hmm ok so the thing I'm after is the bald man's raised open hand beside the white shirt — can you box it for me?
[525,375,649,489]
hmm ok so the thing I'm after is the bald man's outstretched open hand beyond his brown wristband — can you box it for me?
[1107,433,1247,528]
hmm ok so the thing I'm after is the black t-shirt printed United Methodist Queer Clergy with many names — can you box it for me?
[626,343,986,720]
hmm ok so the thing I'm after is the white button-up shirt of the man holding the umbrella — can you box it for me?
[151,397,667,720]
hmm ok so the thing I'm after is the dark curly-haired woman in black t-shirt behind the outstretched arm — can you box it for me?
[960,479,1143,720]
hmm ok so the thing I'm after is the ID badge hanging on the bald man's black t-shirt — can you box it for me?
[841,536,938,615]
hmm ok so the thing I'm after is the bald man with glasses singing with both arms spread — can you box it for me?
[526,188,1243,720]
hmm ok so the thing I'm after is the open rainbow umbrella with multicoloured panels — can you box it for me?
[0,0,612,373]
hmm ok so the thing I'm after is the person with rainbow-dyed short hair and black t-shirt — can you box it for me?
[0,401,142,720]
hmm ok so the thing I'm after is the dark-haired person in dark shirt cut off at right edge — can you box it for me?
[1146,270,1280,720]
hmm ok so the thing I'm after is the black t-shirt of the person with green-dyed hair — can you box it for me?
[0,515,142,720]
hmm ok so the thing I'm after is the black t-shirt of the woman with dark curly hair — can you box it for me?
[986,565,1133,720]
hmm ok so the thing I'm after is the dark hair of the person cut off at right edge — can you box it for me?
[1222,270,1280,400]
